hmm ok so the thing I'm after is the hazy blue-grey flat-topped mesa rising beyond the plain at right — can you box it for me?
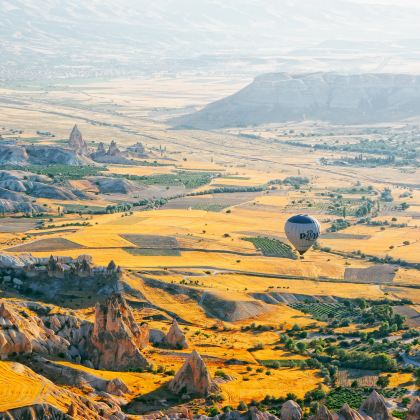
[171,72,420,129]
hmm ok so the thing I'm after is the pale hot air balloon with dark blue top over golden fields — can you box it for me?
[284,214,321,255]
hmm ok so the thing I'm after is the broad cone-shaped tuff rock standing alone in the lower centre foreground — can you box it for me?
[168,350,218,396]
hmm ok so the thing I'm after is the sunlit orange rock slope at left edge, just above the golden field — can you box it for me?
[0,302,69,357]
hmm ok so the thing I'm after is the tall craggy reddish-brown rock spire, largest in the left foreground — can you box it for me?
[90,293,149,370]
